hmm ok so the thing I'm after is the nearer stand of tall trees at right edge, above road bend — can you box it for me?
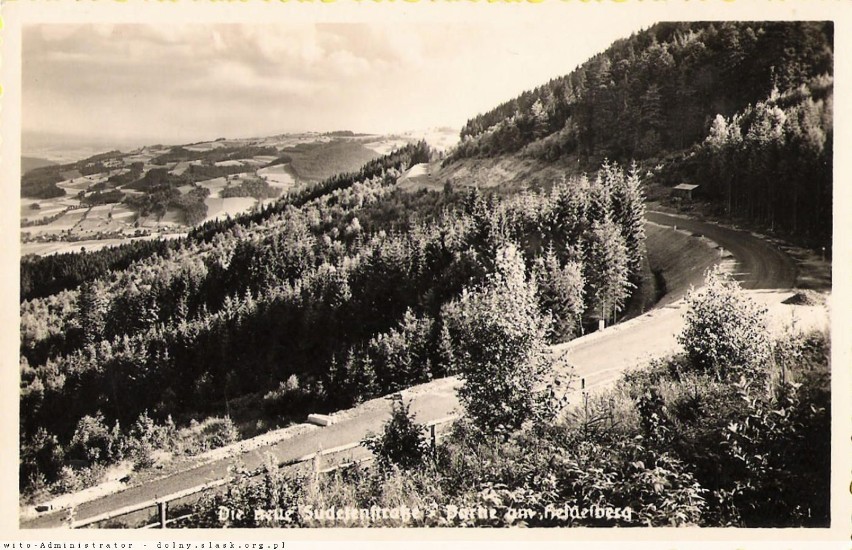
[690,81,834,248]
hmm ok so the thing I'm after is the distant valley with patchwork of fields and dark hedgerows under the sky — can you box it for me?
[20,129,457,256]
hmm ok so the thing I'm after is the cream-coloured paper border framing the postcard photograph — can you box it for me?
[0,0,852,549]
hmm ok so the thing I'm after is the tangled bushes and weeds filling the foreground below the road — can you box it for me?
[185,326,831,527]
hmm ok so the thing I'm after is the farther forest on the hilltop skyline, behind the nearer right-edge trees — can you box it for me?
[451,22,833,164]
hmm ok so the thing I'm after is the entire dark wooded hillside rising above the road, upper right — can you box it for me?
[447,22,834,245]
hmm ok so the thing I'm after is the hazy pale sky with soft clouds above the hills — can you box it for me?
[22,19,647,147]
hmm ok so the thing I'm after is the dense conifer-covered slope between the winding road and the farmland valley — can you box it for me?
[21,137,644,496]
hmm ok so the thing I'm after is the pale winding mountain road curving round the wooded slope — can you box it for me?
[21,212,796,528]
